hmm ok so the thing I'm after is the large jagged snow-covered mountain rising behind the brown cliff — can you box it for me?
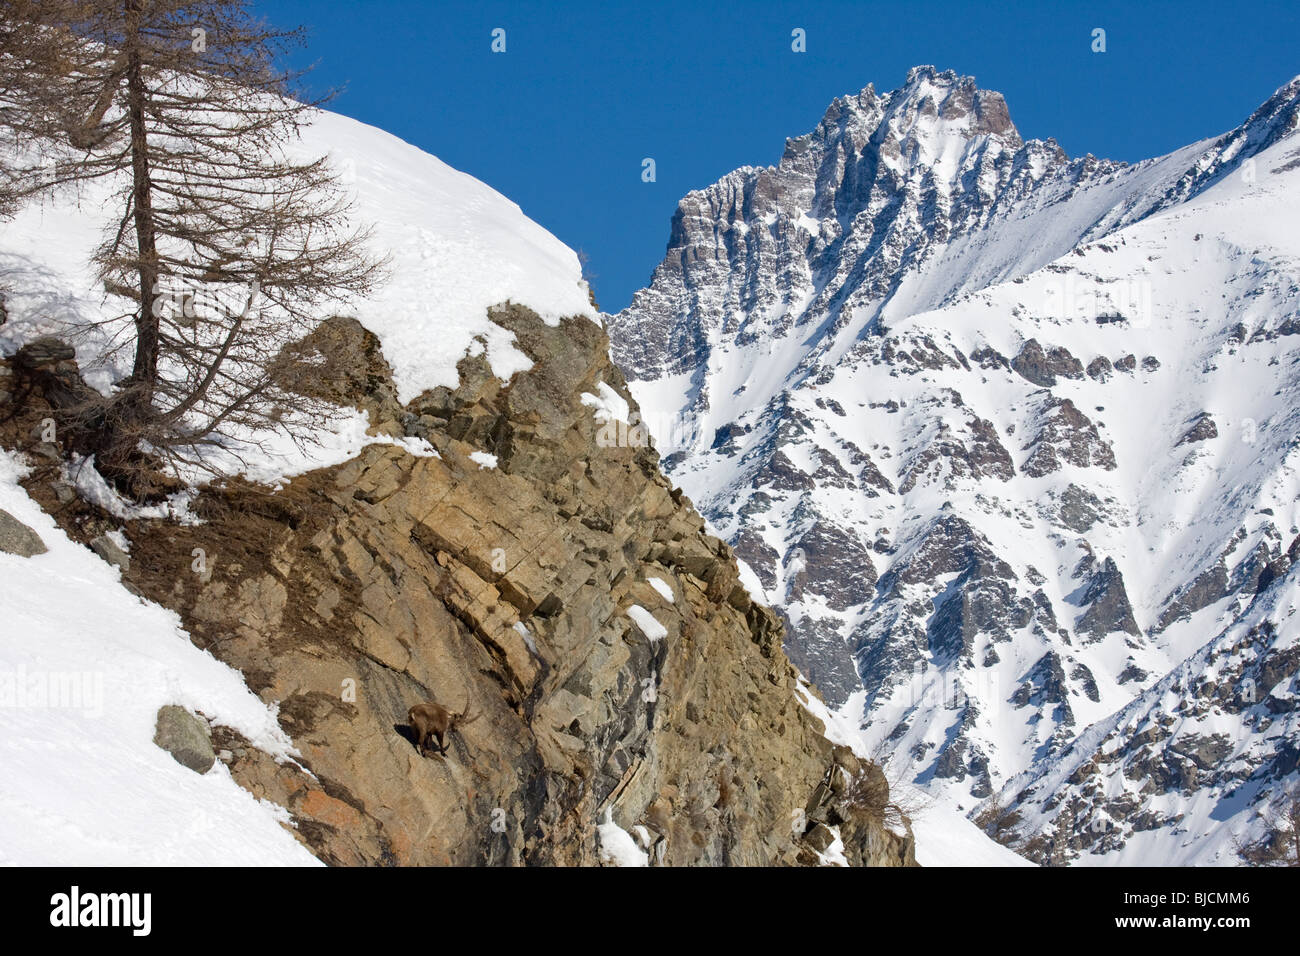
[608,68,1300,862]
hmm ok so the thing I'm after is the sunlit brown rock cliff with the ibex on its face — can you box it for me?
[0,306,915,865]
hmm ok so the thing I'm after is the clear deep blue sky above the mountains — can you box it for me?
[254,0,1300,311]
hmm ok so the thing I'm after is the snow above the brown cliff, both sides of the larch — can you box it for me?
[0,105,595,411]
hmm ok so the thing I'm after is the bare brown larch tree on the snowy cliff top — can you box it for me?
[0,0,382,490]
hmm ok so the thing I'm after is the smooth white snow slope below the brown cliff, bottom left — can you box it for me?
[0,453,317,866]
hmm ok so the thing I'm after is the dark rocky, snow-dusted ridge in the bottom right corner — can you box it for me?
[1004,567,1300,866]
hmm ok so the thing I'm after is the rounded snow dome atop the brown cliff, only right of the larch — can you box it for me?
[303,113,595,402]
